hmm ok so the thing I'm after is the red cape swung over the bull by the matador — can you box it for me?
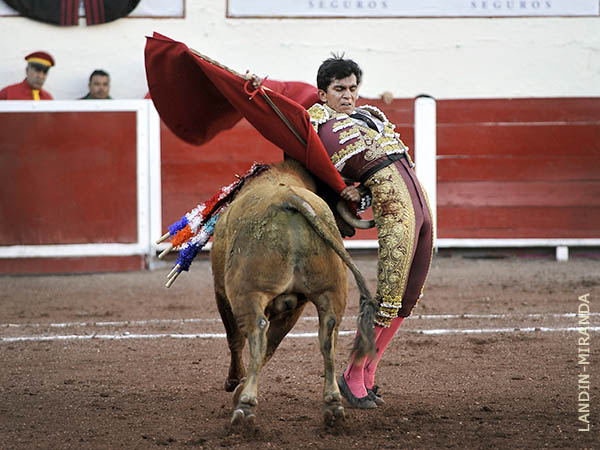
[145,33,346,193]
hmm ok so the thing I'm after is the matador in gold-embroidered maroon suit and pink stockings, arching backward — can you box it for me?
[308,57,433,408]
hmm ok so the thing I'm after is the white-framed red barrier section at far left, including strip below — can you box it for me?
[0,112,143,273]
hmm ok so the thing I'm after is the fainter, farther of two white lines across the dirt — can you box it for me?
[0,313,600,328]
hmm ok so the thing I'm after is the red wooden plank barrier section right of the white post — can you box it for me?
[437,98,600,238]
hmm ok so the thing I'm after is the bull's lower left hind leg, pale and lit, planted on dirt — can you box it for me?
[231,294,269,425]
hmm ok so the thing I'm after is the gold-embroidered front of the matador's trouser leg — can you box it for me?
[365,164,416,327]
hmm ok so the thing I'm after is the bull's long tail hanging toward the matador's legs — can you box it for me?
[286,188,378,360]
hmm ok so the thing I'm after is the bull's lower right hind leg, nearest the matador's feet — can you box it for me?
[315,293,346,425]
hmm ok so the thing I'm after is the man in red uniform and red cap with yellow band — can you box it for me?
[0,52,54,100]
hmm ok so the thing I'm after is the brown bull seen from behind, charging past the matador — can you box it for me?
[211,161,376,425]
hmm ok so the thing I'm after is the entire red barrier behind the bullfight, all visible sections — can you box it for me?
[0,98,600,273]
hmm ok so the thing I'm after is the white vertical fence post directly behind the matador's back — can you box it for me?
[415,95,437,246]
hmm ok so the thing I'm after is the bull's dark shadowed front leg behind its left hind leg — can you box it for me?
[215,289,246,392]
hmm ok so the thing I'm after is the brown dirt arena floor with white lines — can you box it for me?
[0,252,600,450]
